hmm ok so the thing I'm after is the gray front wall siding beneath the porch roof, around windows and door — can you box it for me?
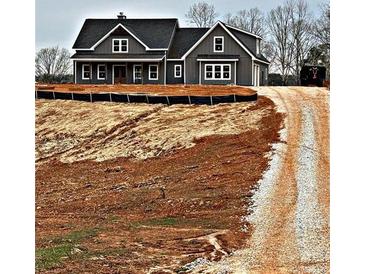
[76,61,164,84]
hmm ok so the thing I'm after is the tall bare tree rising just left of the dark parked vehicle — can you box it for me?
[287,0,315,84]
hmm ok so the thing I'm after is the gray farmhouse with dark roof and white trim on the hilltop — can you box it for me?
[71,13,269,86]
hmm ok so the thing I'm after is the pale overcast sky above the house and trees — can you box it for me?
[35,0,323,50]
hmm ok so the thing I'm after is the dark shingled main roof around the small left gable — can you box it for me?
[72,18,177,49]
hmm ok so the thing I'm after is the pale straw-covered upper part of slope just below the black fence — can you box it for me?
[36,100,268,163]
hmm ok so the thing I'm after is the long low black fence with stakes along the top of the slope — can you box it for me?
[35,90,257,105]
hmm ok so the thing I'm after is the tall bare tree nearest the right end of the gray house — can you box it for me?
[267,3,293,85]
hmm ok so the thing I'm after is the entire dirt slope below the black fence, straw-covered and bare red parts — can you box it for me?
[36,97,283,273]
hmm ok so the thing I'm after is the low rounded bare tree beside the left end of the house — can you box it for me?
[35,46,71,77]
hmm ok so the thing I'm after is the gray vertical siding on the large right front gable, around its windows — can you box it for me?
[185,26,252,85]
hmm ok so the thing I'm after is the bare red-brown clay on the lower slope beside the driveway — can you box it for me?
[36,97,283,273]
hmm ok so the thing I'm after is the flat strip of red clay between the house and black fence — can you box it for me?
[35,84,256,96]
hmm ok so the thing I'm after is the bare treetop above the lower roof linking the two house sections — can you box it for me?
[185,2,218,28]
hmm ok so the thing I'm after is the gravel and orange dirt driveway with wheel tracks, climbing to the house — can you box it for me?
[194,87,330,273]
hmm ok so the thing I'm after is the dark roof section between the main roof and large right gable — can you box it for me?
[168,28,209,59]
